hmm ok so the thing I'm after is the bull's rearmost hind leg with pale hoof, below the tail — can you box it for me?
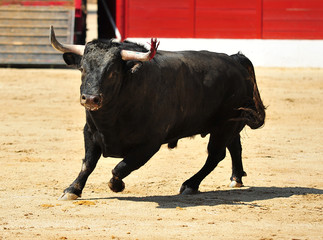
[228,134,247,187]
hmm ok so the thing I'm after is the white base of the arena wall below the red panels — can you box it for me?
[128,38,323,68]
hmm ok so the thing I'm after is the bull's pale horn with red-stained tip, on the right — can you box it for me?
[121,38,159,62]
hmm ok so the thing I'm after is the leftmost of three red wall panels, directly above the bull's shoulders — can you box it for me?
[127,0,194,37]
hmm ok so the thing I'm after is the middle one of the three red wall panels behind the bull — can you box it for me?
[195,0,260,38]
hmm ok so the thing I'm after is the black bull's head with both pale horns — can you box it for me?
[50,26,158,111]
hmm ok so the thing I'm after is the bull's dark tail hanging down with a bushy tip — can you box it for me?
[231,53,266,129]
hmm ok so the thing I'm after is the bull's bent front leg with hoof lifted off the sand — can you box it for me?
[109,144,161,192]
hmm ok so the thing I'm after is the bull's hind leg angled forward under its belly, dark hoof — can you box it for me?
[180,133,226,194]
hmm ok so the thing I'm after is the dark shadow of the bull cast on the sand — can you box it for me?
[85,187,323,208]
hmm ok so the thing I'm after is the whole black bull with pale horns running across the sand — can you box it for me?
[51,26,265,200]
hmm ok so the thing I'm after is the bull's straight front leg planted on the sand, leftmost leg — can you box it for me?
[59,124,102,200]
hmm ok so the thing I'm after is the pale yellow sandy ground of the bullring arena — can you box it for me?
[0,68,323,240]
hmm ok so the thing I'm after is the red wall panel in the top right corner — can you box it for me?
[263,0,323,39]
